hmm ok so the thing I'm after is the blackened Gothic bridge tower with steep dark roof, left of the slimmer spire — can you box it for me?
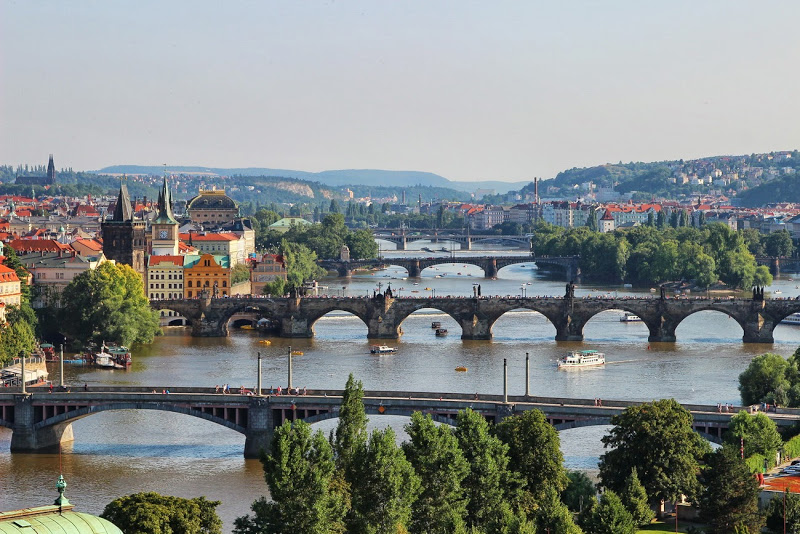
[101,184,145,277]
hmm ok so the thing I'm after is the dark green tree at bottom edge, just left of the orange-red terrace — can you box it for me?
[698,445,764,534]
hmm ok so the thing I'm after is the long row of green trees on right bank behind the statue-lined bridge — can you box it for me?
[532,223,772,288]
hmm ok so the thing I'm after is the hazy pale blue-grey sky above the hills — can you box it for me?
[0,0,800,180]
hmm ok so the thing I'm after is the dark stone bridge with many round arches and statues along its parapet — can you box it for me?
[150,294,800,343]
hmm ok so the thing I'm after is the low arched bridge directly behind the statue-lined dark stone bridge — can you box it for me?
[318,255,581,280]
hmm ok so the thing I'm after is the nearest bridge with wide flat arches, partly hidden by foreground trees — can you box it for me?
[0,386,800,458]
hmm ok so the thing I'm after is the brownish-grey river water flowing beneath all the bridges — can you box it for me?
[0,244,800,531]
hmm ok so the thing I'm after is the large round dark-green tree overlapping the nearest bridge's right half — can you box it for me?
[599,399,709,501]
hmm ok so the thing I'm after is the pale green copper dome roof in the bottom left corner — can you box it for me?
[0,506,122,534]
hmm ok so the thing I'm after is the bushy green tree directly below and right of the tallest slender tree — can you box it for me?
[351,427,420,534]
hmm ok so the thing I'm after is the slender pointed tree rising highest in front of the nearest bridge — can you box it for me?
[331,373,368,484]
